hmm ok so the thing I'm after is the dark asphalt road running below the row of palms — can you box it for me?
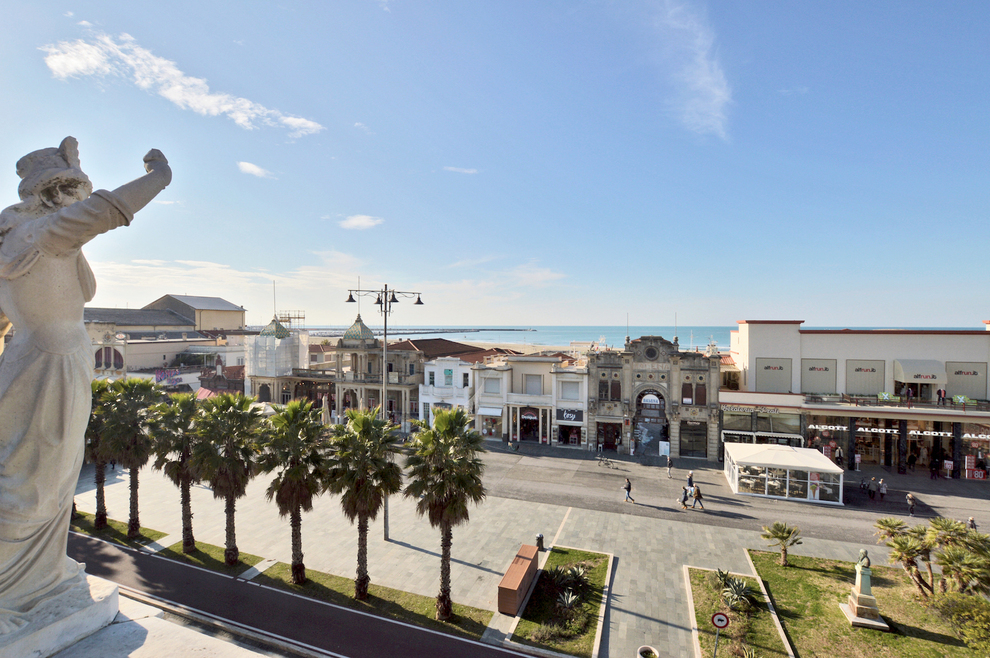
[68,533,524,658]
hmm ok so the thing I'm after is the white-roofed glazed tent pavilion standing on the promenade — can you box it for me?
[724,443,844,505]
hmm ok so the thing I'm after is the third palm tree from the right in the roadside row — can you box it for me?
[258,400,328,585]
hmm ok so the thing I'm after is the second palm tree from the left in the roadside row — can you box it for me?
[101,377,162,539]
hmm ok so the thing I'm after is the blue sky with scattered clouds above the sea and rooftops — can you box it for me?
[0,0,990,328]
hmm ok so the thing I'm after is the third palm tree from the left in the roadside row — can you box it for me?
[151,393,199,553]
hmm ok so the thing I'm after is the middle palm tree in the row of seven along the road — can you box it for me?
[192,393,261,566]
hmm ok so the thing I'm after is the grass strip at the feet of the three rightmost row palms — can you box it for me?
[252,560,494,640]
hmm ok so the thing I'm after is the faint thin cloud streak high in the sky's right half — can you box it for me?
[657,0,732,139]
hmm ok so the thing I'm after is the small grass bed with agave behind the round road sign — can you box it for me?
[688,569,787,658]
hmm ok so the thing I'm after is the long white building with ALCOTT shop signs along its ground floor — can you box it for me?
[719,320,990,479]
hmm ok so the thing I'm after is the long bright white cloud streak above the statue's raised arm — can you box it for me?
[41,34,324,138]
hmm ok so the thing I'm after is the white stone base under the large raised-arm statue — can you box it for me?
[0,575,118,658]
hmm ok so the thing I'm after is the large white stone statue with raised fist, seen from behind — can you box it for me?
[0,137,172,638]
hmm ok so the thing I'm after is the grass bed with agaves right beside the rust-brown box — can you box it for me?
[512,548,608,657]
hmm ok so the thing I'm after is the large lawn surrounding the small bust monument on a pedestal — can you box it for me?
[750,551,980,658]
